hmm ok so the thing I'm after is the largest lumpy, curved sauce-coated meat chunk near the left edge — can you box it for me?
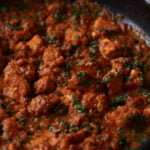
[3,59,31,100]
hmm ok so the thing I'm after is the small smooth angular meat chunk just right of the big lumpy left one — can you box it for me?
[34,76,56,94]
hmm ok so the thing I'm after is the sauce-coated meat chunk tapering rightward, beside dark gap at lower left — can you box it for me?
[28,95,59,116]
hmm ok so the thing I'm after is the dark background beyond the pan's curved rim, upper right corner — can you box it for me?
[93,0,150,37]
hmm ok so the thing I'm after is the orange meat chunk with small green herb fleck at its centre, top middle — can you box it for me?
[65,28,88,45]
